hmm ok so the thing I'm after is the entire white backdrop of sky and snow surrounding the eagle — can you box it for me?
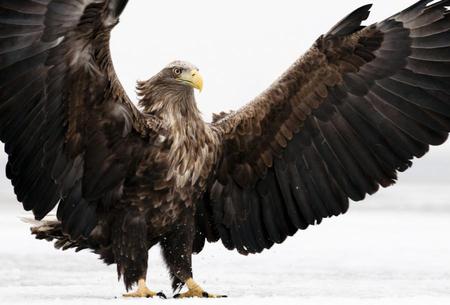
[0,0,450,304]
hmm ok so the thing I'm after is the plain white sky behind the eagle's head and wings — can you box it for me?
[0,0,450,202]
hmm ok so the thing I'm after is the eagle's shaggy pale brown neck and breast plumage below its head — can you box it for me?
[140,87,218,187]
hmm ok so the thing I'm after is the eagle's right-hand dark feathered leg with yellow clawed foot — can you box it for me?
[161,222,226,298]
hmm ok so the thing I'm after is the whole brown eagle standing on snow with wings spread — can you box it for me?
[0,0,450,298]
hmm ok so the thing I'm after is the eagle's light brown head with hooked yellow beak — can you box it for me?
[137,61,203,112]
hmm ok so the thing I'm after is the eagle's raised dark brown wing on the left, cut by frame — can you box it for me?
[0,0,158,238]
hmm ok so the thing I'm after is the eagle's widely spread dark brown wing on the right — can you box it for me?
[195,0,450,254]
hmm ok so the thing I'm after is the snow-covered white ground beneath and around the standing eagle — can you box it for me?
[0,185,450,305]
